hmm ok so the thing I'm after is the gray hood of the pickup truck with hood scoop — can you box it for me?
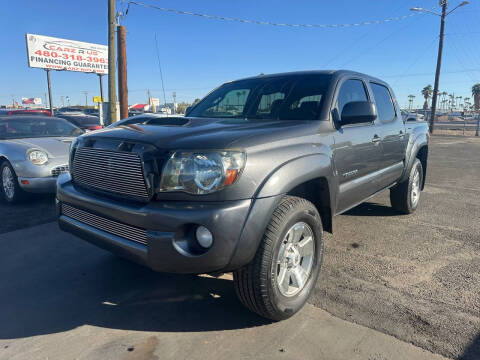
[82,118,315,150]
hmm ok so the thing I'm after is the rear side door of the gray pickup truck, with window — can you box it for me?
[370,82,407,187]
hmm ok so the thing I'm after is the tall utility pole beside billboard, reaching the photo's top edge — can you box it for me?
[107,0,117,124]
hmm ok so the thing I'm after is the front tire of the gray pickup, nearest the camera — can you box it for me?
[233,196,323,321]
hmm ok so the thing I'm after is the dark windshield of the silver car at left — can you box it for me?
[0,116,83,140]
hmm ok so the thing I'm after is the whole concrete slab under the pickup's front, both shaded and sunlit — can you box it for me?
[0,223,444,360]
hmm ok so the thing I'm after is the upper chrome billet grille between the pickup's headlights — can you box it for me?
[73,147,149,200]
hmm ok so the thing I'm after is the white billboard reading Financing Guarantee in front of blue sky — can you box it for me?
[25,34,108,74]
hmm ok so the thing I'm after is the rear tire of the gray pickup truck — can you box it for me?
[390,159,423,214]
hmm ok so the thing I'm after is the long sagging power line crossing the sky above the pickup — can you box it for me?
[127,1,419,28]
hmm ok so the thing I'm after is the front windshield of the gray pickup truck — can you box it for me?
[188,74,331,120]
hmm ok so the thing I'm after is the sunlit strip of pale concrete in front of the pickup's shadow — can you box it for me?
[0,305,445,360]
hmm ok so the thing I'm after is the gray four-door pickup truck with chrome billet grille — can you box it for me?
[57,71,429,320]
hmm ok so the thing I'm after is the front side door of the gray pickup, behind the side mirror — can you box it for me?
[332,78,383,213]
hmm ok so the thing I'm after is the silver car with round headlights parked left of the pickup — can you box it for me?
[0,115,83,203]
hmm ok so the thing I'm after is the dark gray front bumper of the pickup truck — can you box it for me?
[57,176,282,273]
